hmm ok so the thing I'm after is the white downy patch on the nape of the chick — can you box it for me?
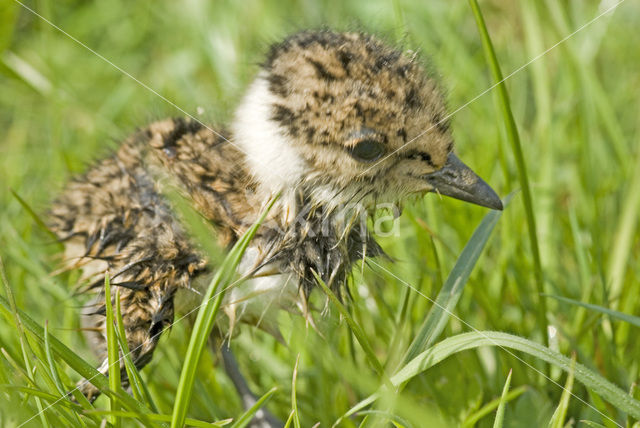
[232,73,304,194]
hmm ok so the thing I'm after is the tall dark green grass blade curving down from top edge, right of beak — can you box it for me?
[469,0,547,340]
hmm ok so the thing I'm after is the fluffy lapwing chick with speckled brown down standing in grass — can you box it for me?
[50,31,502,399]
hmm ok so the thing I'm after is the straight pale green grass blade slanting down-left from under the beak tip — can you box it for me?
[402,205,502,364]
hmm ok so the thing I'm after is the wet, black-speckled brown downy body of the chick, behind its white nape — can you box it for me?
[50,119,252,398]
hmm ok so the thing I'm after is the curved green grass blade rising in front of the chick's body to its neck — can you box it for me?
[171,197,277,428]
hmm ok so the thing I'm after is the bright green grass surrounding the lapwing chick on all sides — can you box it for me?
[0,0,640,427]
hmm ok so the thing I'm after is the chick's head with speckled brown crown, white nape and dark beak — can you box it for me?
[233,31,502,214]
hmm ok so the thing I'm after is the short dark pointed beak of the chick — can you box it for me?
[425,153,502,211]
